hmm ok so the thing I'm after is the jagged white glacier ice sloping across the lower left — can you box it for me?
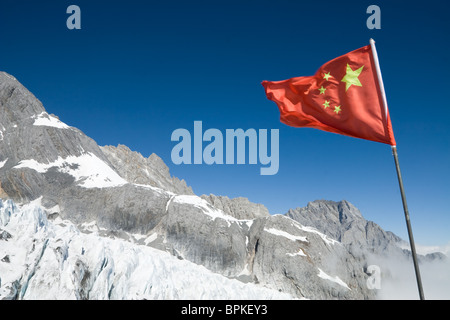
[0,199,293,300]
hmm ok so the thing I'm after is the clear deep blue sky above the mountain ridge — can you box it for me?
[0,0,450,245]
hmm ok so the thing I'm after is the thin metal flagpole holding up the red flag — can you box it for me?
[370,39,425,300]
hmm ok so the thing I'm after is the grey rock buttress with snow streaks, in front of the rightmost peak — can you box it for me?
[244,215,375,299]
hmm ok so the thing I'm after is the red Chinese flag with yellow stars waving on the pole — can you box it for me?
[262,45,395,146]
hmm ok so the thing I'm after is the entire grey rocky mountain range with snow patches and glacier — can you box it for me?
[0,72,444,299]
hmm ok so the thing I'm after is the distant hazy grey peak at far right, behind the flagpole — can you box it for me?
[286,200,447,290]
